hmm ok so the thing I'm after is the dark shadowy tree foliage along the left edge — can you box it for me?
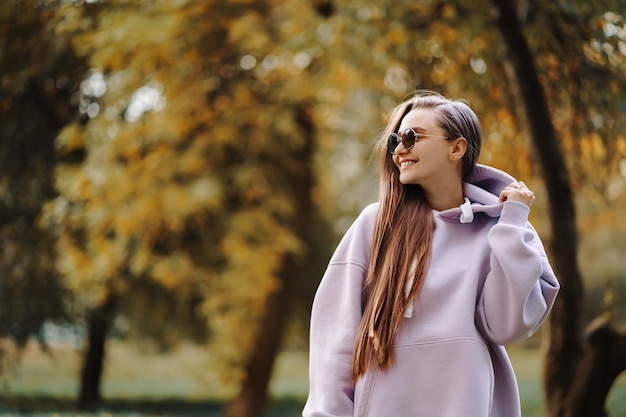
[0,1,84,364]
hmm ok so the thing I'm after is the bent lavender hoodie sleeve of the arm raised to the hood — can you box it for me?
[476,202,559,345]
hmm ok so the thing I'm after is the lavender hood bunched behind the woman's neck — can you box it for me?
[438,164,516,223]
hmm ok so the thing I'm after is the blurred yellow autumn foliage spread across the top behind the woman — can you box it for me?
[36,0,626,390]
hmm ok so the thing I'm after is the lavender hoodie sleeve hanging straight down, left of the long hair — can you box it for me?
[302,205,376,417]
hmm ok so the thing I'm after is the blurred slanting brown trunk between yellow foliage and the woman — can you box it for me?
[224,105,314,417]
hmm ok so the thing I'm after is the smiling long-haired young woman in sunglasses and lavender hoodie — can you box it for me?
[303,93,559,417]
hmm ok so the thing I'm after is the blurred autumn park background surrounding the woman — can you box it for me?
[0,0,626,417]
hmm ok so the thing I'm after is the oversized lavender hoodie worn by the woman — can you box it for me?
[303,165,559,417]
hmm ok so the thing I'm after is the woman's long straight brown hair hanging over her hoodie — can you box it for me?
[352,91,481,381]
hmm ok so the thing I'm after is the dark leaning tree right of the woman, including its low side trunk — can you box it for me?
[493,0,626,417]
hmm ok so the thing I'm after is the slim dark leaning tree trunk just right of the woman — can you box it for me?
[492,0,583,417]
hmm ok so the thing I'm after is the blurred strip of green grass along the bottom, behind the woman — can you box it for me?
[0,342,626,417]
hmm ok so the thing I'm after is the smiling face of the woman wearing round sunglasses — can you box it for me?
[393,108,457,187]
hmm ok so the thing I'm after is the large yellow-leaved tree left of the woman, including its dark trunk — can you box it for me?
[46,1,324,412]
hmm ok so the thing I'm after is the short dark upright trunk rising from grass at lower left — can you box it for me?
[78,296,115,411]
